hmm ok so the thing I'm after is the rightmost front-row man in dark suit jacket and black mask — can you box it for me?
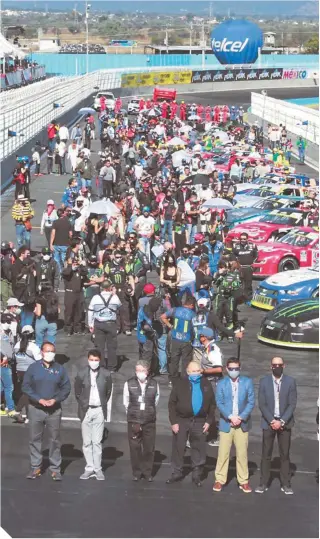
[256,357,297,494]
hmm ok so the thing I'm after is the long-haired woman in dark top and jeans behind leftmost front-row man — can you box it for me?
[34,283,60,348]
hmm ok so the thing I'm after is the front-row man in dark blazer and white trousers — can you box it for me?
[74,350,112,481]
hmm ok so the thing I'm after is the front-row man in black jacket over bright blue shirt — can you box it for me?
[167,361,215,487]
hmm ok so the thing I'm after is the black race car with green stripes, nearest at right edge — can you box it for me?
[257,298,319,350]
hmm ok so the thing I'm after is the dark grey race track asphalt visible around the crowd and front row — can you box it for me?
[1,89,318,538]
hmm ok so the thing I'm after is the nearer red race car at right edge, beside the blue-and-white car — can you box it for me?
[252,227,319,277]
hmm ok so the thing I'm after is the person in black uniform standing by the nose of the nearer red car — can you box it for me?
[232,232,258,301]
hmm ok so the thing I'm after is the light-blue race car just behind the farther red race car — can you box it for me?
[227,196,304,227]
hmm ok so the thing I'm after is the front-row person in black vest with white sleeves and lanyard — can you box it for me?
[123,360,160,482]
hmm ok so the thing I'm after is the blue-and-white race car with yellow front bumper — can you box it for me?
[251,268,319,311]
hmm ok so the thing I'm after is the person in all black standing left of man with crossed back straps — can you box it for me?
[61,251,88,337]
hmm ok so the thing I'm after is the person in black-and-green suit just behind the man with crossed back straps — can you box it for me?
[104,251,135,336]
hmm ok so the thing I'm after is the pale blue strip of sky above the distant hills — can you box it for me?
[2,0,318,16]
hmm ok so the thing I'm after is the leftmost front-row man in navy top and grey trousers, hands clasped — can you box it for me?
[22,342,71,481]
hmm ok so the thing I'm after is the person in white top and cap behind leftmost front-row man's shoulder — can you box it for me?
[14,326,42,423]
